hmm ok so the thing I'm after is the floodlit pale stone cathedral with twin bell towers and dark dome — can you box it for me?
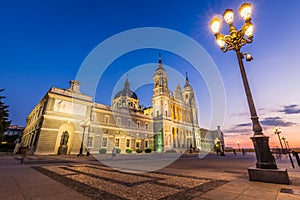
[21,56,224,155]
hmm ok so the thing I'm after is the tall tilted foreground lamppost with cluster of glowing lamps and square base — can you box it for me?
[210,3,289,184]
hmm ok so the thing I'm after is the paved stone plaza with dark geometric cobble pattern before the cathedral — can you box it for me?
[0,153,300,200]
